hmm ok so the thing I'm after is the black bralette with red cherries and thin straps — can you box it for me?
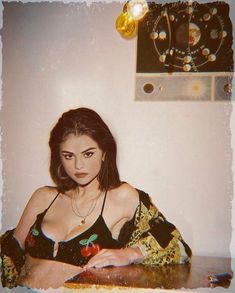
[25,192,120,266]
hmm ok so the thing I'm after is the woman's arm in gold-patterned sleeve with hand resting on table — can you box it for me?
[85,187,191,268]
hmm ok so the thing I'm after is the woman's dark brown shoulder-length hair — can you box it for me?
[49,108,120,192]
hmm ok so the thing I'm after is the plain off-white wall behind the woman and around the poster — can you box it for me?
[1,2,235,256]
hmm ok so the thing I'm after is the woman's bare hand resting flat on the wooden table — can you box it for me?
[84,247,143,269]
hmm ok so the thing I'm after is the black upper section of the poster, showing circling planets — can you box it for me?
[137,2,233,72]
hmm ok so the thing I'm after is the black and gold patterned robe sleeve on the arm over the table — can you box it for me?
[119,191,192,265]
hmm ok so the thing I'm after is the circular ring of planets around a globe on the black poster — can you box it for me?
[149,2,228,72]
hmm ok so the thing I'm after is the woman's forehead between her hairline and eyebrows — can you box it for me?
[60,133,99,151]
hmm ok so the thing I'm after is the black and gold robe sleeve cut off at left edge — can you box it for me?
[1,229,25,288]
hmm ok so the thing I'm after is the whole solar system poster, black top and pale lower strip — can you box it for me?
[136,1,233,100]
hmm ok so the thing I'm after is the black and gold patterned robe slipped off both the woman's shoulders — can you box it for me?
[1,191,192,288]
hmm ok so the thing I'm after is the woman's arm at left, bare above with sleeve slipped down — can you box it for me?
[1,187,55,288]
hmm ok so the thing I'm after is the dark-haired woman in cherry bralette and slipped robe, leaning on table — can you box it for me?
[1,108,191,288]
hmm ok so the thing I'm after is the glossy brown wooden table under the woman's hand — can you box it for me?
[64,256,233,289]
